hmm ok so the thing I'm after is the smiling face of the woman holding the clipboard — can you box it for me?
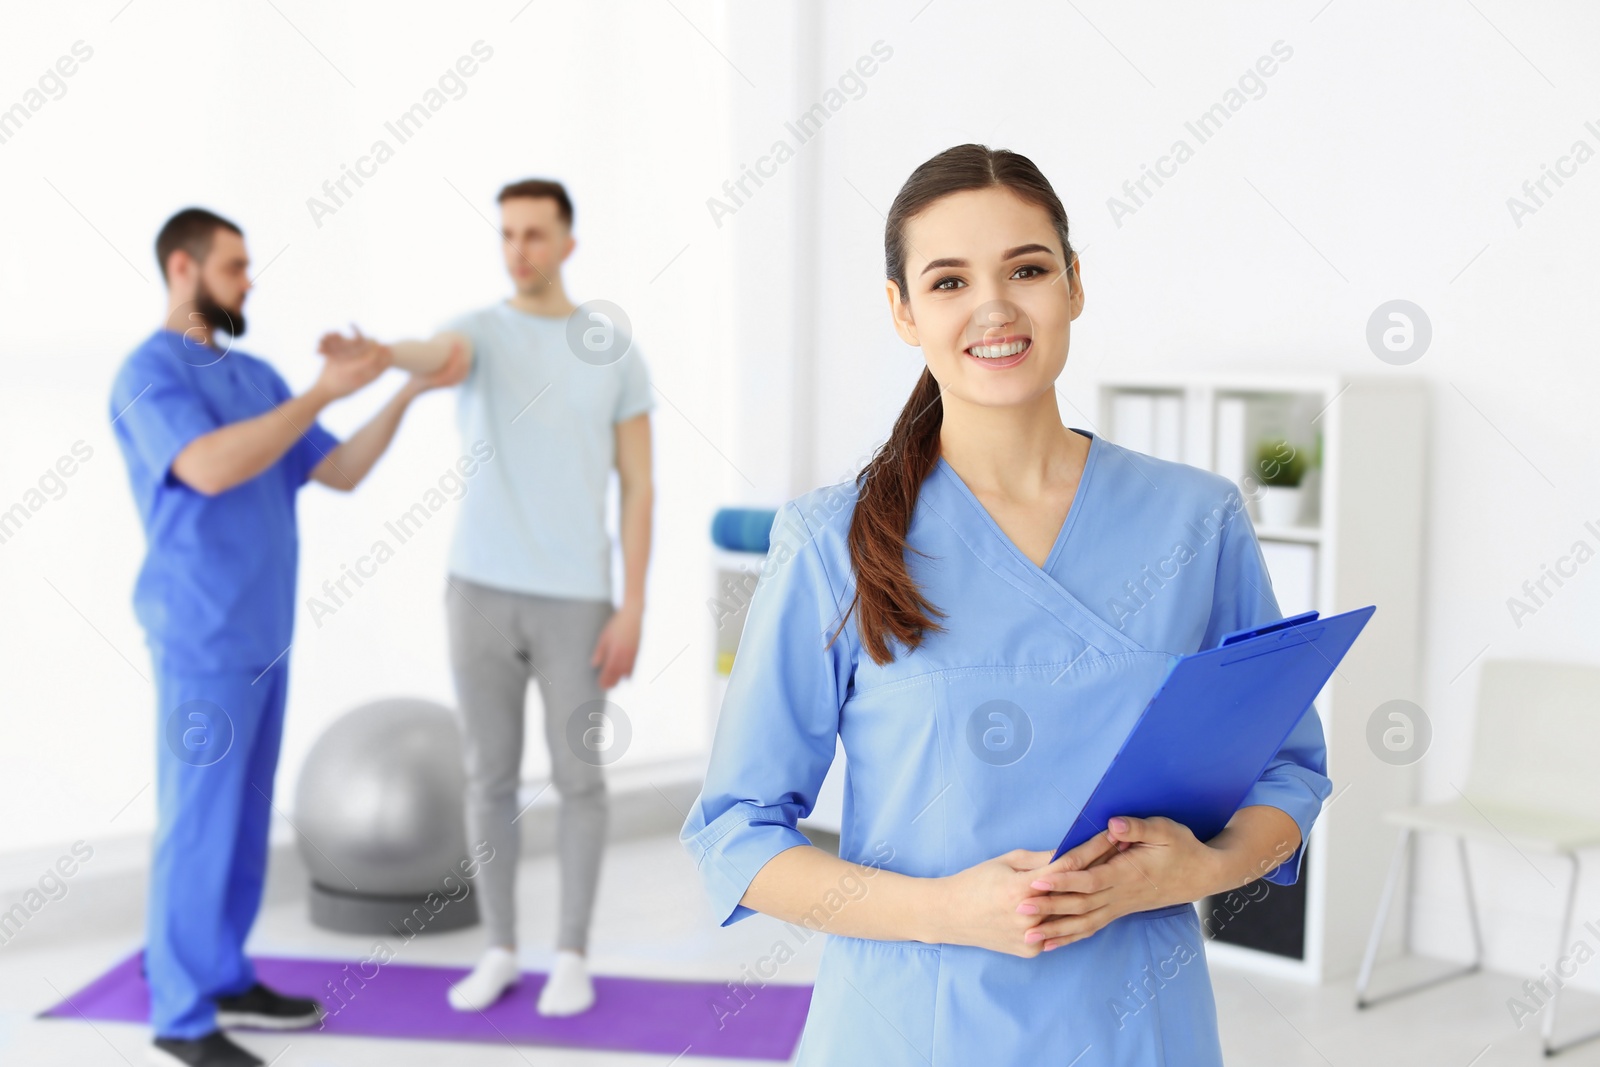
[886,186,1083,406]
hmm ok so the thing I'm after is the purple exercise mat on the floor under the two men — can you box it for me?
[43,952,811,1061]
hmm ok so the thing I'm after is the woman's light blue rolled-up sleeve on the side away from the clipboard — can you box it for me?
[680,502,853,926]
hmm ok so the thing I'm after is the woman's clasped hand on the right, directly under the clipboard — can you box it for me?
[1018,816,1222,952]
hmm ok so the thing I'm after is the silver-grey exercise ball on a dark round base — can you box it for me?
[294,697,478,936]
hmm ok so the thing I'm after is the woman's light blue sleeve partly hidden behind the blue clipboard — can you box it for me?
[1203,495,1333,885]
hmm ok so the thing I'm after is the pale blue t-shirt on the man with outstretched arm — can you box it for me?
[440,302,654,600]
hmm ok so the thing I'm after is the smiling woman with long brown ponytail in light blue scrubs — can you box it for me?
[683,144,1331,1067]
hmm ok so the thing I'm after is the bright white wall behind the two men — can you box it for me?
[0,0,733,853]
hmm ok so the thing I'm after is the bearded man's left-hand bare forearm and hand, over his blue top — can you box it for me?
[173,343,387,496]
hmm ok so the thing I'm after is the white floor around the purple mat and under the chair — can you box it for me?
[0,837,1600,1067]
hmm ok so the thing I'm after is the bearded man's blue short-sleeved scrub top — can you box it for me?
[110,328,339,672]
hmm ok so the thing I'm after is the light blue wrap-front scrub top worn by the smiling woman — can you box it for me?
[683,430,1331,1067]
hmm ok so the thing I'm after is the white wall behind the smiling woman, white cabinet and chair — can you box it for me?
[723,0,1600,987]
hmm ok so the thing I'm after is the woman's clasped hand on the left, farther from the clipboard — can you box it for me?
[938,838,1107,957]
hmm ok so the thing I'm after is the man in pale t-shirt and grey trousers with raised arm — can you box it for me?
[323,179,654,1016]
